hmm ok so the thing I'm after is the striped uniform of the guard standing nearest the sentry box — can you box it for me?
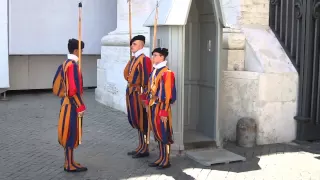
[147,66,176,166]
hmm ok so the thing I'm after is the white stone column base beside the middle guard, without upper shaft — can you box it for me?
[95,31,150,112]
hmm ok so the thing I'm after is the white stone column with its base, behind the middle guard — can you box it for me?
[95,0,156,112]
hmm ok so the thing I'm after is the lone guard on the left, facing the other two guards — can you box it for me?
[53,39,87,172]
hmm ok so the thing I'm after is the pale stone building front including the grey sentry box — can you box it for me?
[96,0,299,150]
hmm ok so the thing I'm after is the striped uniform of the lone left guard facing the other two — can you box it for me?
[54,59,86,170]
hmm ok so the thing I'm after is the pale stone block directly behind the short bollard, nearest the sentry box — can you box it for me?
[219,71,259,141]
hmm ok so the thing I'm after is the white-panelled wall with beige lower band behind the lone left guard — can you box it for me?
[0,0,117,93]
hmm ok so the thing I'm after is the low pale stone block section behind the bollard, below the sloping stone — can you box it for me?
[219,71,298,145]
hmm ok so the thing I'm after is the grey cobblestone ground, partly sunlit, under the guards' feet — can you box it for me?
[0,90,320,180]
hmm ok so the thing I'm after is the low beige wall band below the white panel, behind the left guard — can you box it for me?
[8,55,99,90]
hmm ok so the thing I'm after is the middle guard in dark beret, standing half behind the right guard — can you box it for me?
[124,35,152,158]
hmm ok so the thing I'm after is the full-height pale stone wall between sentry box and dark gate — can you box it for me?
[219,0,298,144]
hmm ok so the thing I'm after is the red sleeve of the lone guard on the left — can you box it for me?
[67,63,86,112]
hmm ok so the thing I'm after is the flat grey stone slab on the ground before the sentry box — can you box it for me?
[186,148,246,166]
